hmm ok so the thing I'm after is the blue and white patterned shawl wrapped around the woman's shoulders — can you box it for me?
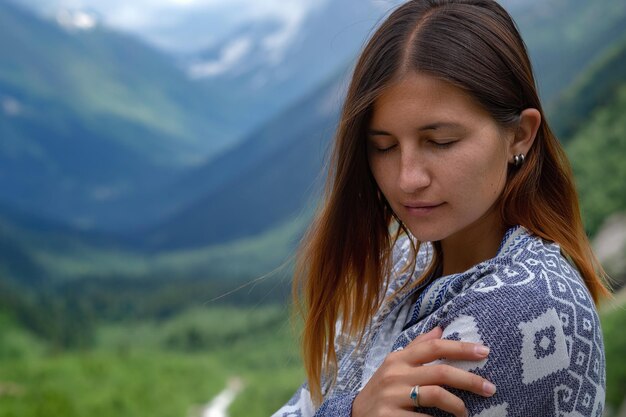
[273,226,605,417]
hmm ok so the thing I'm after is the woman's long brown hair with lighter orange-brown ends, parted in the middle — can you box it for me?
[294,0,608,402]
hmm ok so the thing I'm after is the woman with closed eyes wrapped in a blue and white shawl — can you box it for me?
[275,0,607,417]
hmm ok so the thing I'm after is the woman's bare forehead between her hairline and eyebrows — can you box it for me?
[370,72,491,125]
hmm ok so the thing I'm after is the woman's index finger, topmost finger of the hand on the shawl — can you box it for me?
[404,339,489,364]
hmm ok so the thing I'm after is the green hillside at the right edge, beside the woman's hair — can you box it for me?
[563,38,626,235]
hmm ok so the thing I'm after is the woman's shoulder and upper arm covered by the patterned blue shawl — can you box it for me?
[426,234,605,415]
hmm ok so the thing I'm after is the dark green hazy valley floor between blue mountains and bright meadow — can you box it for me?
[0,203,307,334]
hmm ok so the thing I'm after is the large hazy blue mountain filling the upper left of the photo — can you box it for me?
[0,1,241,230]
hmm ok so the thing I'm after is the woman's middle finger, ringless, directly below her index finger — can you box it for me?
[411,365,496,397]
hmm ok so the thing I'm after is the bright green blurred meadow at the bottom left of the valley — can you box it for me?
[0,306,303,417]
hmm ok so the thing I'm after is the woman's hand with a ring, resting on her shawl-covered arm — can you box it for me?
[352,327,496,417]
